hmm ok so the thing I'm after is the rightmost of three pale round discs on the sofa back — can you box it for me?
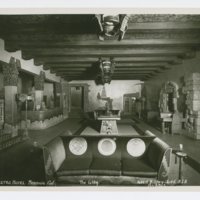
[126,138,146,157]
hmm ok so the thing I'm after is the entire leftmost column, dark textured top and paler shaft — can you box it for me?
[3,57,19,137]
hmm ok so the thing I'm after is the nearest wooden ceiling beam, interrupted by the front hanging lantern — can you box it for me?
[2,21,200,34]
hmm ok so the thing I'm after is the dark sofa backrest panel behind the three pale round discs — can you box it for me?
[62,135,155,160]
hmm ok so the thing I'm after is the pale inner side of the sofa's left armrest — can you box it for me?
[46,137,66,171]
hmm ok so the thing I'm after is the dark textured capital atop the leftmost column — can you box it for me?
[3,57,20,86]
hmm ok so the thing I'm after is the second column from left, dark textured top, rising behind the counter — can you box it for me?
[34,71,45,110]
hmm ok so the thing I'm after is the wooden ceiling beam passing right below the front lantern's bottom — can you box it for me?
[5,36,200,50]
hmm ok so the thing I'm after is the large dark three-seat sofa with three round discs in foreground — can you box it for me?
[43,132,172,186]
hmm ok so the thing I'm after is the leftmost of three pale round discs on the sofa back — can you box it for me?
[69,137,87,156]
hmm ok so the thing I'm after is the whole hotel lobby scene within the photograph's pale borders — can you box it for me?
[0,14,200,186]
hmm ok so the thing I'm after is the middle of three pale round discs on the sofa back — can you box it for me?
[98,138,116,156]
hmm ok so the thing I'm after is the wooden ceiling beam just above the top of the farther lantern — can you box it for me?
[22,48,192,58]
